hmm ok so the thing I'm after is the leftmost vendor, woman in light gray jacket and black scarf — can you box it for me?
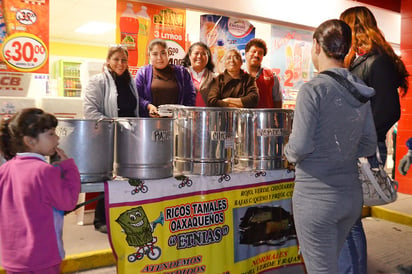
[83,46,139,233]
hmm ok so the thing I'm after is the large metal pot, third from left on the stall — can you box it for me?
[175,107,235,176]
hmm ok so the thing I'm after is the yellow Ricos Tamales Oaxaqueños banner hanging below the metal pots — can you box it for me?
[105,170,304,273]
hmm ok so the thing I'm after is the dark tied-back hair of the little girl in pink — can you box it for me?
[0,108,57,160]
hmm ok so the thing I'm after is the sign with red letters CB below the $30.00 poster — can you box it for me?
[0,72,31,97]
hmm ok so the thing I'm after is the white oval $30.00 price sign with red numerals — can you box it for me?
[1,32,48,71]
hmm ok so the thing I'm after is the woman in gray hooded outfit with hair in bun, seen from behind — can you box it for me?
[285,20,376,274]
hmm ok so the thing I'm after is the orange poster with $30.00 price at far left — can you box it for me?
[0,0,49,74]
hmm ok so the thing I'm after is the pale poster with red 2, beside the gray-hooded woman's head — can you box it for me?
[270,25,313,109]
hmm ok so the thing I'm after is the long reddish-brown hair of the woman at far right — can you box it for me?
[340,6,409,96]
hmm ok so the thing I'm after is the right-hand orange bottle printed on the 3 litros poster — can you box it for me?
[136,6,151,67]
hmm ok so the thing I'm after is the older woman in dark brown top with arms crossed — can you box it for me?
[207,49,259,108]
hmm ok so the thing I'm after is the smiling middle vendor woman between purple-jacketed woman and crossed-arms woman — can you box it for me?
[183,42,215,107]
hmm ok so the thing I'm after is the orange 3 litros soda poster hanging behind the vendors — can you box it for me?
[116,0,186,75]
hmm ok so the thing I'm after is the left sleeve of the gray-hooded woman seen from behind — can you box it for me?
[285,84,319,163]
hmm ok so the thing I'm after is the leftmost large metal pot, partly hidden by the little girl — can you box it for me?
[56,118,114,183]
